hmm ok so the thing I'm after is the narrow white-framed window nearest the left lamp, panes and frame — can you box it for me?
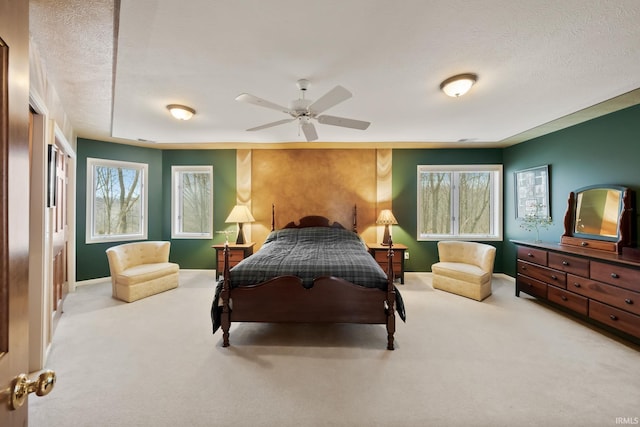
[171,166,213,239]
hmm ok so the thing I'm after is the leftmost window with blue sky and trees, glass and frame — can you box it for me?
[86,158,149,243]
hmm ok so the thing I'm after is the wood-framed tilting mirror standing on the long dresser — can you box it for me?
[561,185,633,253]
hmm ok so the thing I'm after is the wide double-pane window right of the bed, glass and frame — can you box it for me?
[417,165,502,240]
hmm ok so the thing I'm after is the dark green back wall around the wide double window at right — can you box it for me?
[392,148,503,272]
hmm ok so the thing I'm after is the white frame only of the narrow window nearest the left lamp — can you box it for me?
[171,165,213,240]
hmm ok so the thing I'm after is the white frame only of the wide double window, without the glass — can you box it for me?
[416,164,504,242]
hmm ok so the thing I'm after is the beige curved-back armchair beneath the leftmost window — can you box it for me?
[106,241,180,302]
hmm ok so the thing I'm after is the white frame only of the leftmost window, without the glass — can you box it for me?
[85,157,149,244]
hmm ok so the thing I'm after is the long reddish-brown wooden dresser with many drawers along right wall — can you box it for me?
[513,241,640,341]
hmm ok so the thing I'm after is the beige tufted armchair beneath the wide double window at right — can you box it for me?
[431,241,496,301]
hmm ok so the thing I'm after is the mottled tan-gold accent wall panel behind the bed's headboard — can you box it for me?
[251,149,384,249]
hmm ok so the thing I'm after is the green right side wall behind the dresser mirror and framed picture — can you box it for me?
[502,105,640,276]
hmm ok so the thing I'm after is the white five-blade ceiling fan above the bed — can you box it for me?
[236,79,370,141]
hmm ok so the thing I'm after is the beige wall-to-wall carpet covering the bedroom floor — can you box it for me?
[29,271,640,427]
